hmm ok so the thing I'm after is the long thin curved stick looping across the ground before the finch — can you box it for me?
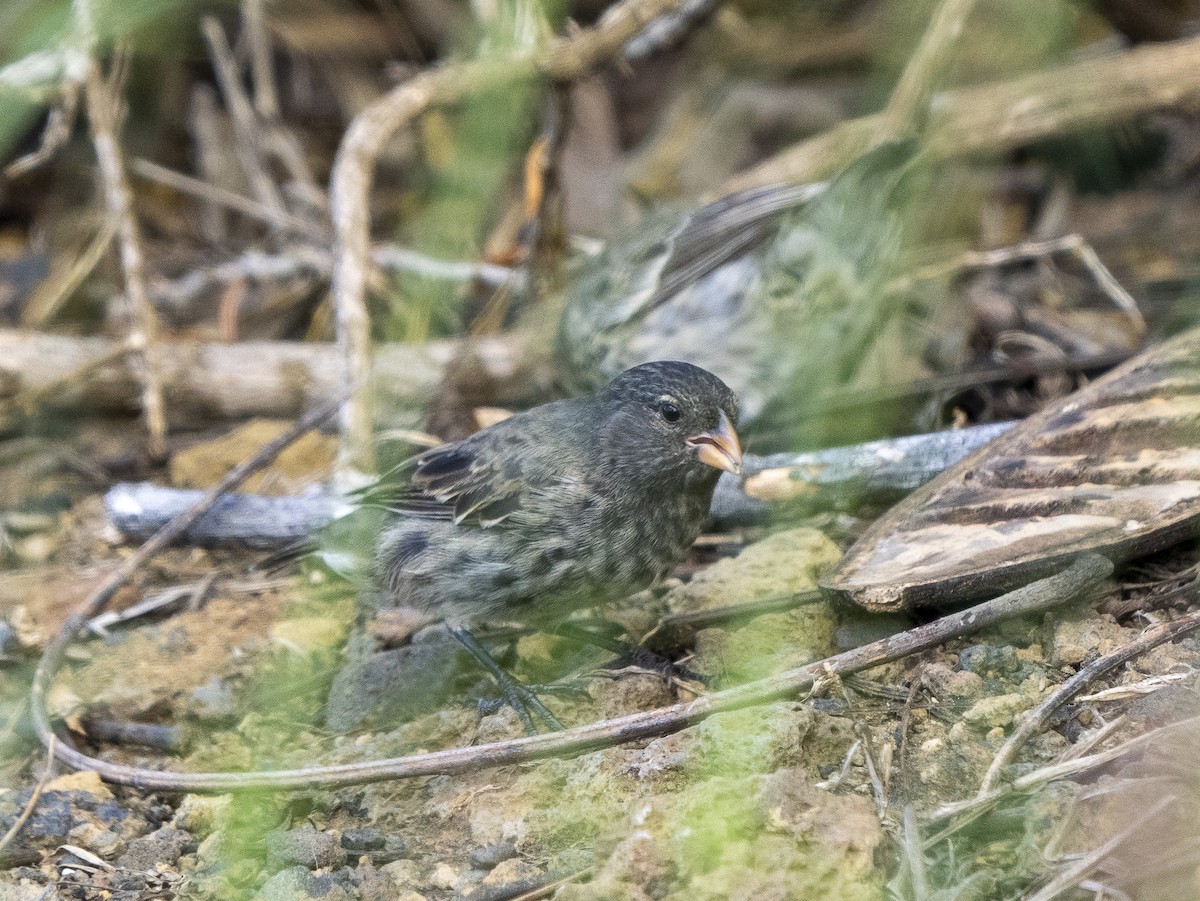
[30,549,1112,792]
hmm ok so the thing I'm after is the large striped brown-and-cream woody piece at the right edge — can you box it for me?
[822,329,1200,611]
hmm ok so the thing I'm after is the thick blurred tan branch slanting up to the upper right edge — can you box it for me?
[719,37,1200,194]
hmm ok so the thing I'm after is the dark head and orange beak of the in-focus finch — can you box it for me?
[602,361,742,482]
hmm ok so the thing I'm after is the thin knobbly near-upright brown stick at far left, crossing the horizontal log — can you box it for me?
[84,54,167,459]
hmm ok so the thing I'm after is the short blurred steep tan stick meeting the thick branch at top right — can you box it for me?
[875,0,976,144]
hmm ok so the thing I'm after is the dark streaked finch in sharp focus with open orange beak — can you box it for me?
[376,361,742,629]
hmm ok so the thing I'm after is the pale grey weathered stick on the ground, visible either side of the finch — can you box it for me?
[104,422,1012,547]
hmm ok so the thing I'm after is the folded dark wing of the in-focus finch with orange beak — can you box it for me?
[358,404,575,528]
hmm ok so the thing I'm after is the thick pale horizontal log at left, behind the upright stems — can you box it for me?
[0,329,523,422]
